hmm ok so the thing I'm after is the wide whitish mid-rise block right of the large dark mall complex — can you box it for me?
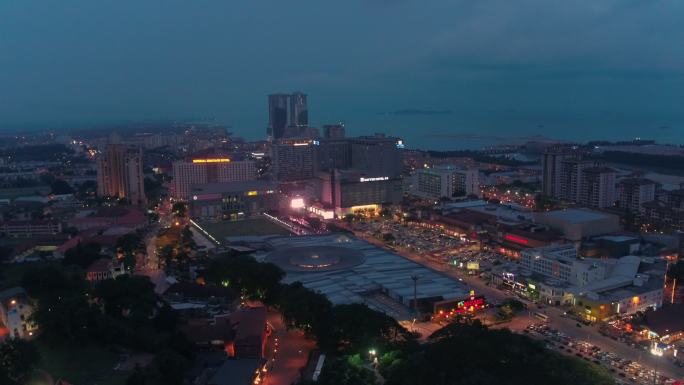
[413,167,480,199]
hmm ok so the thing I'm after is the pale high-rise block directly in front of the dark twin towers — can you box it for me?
[271,138,316,182]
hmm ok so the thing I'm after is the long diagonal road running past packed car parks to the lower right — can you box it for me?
[356,226,684,379]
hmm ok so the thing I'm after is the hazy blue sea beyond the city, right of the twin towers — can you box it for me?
[345,114,684,150]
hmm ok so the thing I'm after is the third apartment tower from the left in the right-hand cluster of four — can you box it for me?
[578,166,616,209]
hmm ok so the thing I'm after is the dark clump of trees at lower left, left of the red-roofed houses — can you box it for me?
[22,266,193,384]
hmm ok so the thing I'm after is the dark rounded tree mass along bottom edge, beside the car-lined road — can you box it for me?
[380,321,615,385]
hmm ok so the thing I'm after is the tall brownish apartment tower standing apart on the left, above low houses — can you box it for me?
[97,144,147,205]
